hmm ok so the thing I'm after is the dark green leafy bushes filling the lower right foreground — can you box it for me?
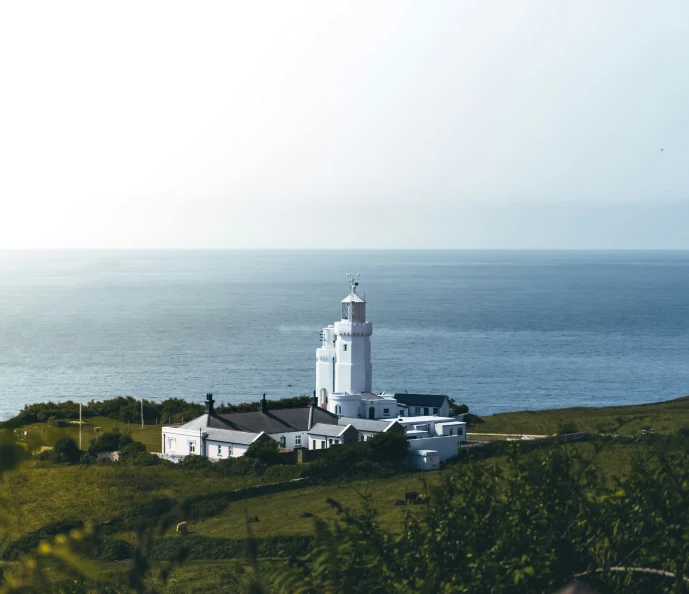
[264,434,689,594]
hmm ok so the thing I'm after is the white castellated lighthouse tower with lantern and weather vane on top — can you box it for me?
[316,274,373,416]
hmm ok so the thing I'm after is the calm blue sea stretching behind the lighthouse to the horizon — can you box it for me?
[0,251,689,419]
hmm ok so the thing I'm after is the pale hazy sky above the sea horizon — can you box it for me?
[0,0,689,248]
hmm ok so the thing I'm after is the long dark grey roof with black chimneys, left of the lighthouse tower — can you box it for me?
[210,406,337,433]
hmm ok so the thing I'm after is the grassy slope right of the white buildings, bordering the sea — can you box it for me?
[469,396,689,435]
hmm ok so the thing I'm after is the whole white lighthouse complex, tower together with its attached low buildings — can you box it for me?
[163,275,466,460]
